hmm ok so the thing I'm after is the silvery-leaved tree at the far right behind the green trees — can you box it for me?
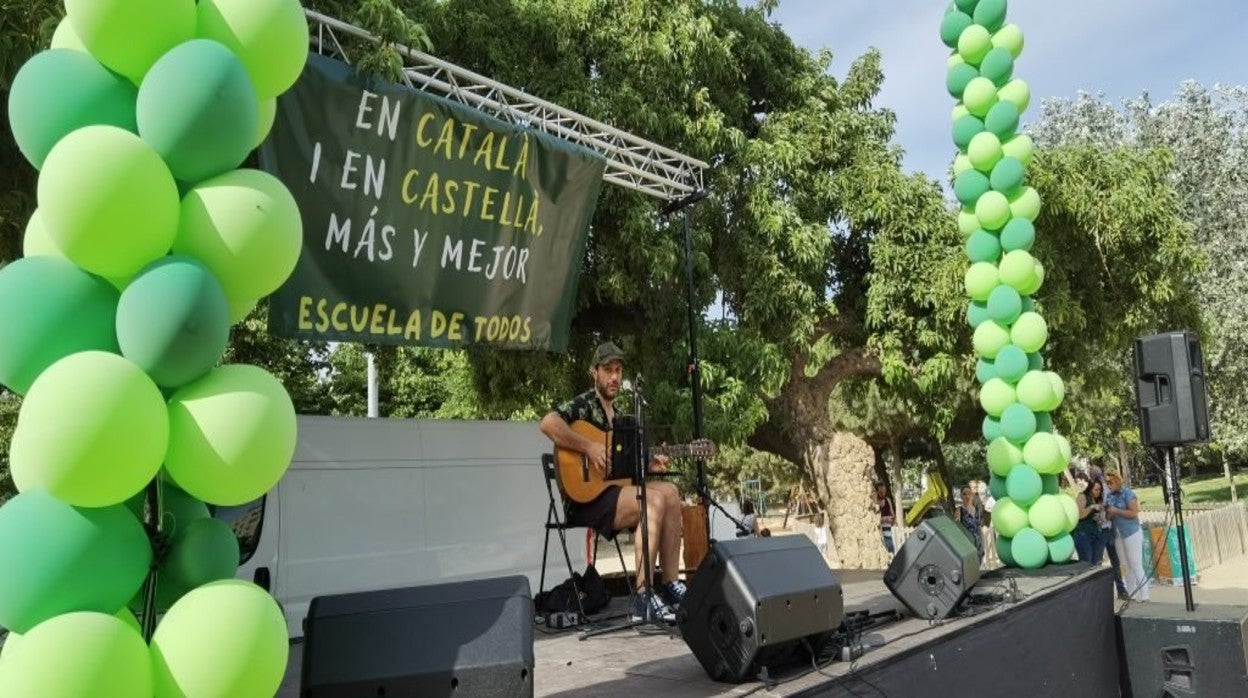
[1033,81,1248,458]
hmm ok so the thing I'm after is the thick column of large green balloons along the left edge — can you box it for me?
[0,0,307,698]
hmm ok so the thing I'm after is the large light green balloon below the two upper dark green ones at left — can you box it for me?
[37,126,178,277]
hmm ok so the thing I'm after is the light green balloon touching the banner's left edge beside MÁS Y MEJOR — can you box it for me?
[173,170,303,303]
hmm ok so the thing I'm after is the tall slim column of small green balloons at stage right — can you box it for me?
[940,0,1078,568]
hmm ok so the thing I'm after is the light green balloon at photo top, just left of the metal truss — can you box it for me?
[198,0,310,100]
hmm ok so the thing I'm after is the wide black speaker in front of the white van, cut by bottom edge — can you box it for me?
[302,577,533,698]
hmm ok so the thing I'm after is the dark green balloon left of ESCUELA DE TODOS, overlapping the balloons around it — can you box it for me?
[117,256,230,387]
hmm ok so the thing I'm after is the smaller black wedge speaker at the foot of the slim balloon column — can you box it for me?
[884,516,980,619]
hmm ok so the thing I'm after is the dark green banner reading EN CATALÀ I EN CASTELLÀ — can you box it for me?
[260,55,605,351]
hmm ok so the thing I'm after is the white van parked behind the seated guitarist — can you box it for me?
[215,417,585,638]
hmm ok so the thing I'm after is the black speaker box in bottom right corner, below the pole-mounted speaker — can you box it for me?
[1117,603,1248,698]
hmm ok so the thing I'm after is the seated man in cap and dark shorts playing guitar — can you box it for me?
[539,342,685,623]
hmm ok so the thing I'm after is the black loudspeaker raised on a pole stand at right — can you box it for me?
[1134,332,1209,446]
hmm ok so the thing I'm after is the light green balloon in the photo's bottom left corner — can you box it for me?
[0,612,152,698]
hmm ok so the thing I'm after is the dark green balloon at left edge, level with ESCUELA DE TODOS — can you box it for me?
[0,257,117,395]
